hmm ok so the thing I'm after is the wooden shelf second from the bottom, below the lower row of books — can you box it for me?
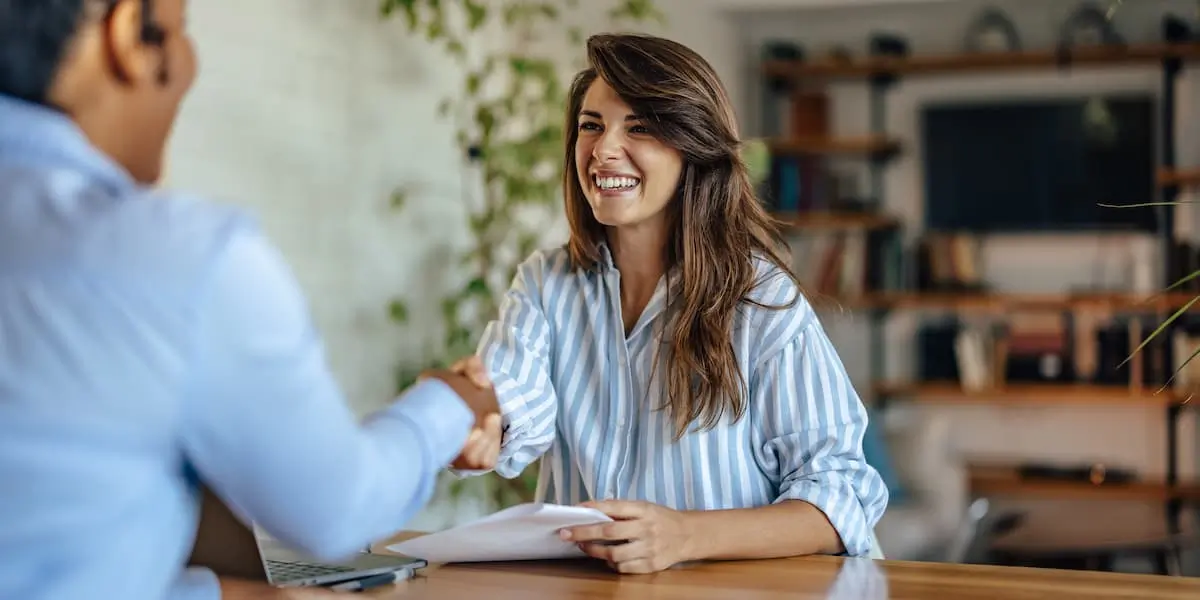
[874,382,1189,406]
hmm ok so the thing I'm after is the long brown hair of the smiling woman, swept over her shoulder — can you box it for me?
[563,34,799,439]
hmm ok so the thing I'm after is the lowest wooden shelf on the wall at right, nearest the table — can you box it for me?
[967,464,1200,500]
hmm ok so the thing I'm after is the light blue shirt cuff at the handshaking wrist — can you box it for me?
[384,378,475,467]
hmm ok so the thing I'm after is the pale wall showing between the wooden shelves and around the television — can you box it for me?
[730,0,1200,474]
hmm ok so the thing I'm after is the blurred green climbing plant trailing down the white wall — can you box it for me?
[380,0,665,506]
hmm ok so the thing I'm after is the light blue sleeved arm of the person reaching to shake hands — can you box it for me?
[180,232,474,559]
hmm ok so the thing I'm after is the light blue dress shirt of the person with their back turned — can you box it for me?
[0,96,473,600]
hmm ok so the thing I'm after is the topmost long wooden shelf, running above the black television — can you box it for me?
[762,43,1200,79]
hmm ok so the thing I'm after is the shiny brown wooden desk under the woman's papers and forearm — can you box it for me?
[350,532,1200,600]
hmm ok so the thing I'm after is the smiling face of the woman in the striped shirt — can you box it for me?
[575,78,683,227]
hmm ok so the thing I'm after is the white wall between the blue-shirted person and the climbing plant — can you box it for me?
[169,0,487,412]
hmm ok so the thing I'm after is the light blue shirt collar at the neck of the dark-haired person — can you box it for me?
[0,94,136,188]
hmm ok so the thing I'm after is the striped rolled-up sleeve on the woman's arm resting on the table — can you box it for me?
[751,318,888,557]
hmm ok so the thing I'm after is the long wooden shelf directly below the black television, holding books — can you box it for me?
[838,293,1200,312]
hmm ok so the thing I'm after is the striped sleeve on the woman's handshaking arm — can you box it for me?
[470,254,558,479]
